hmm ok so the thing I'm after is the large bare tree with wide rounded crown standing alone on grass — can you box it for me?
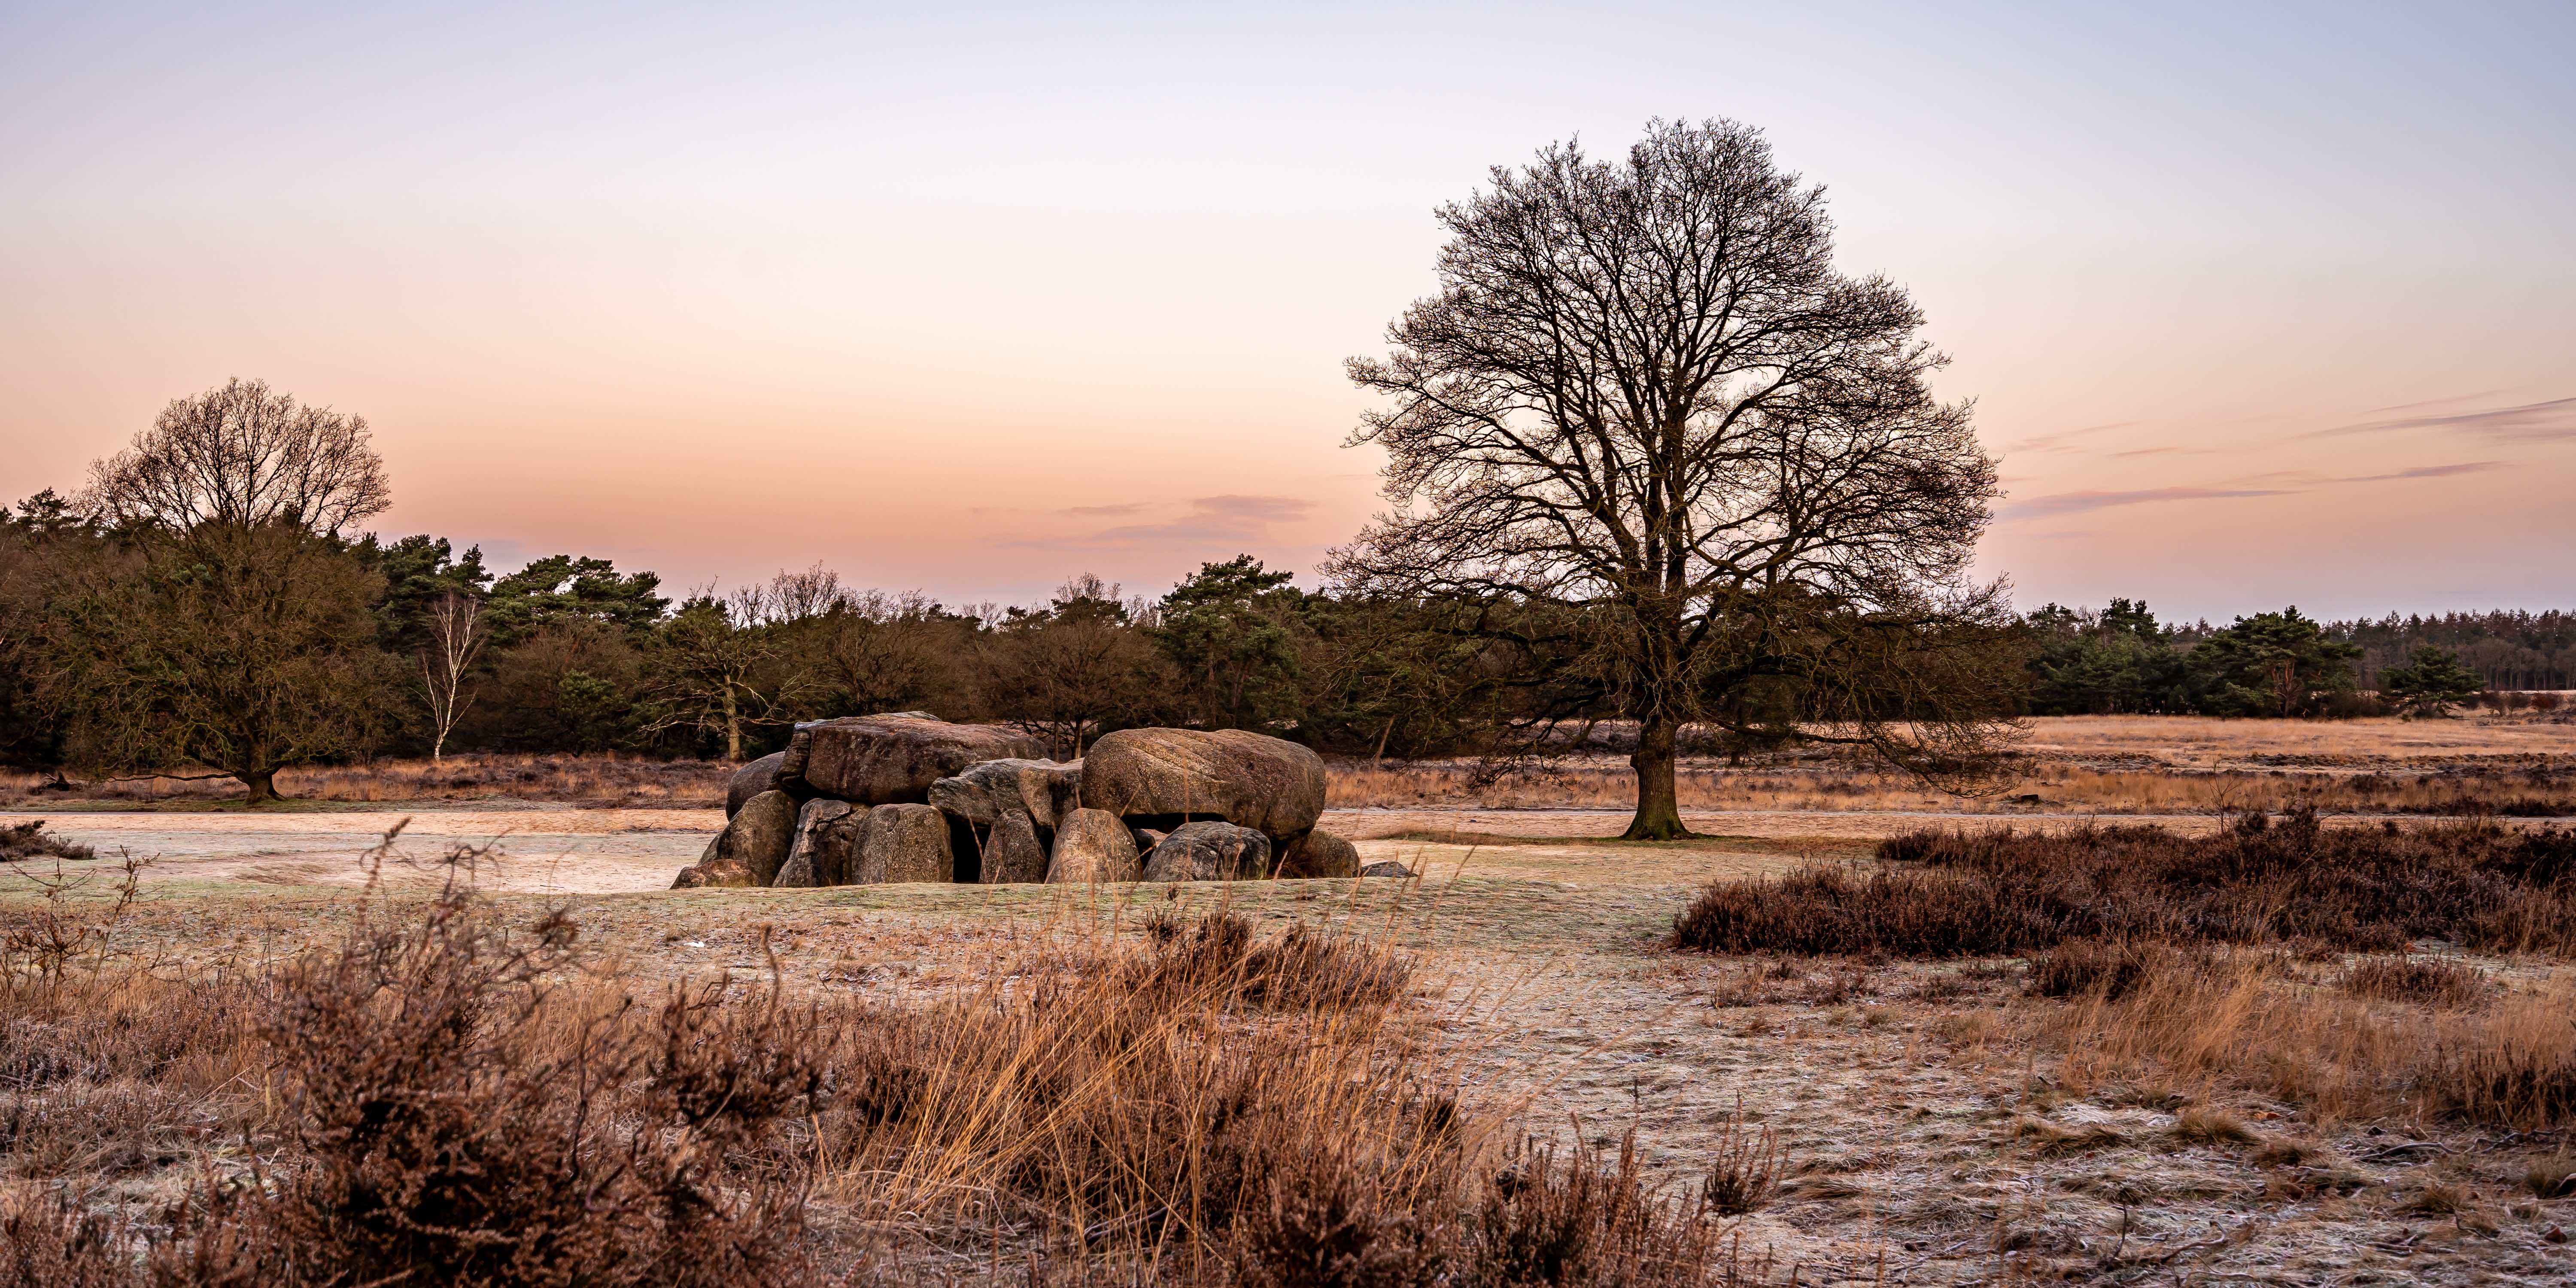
[1329,121,2004,840]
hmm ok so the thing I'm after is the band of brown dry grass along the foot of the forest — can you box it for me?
[20,716,2576,817]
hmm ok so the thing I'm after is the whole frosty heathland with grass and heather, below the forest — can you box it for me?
[0,719,2576,1283]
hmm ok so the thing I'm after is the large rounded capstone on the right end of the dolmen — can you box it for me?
[1082,729,1324,840]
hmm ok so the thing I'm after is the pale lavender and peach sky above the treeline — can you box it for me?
[0,0,2576,621]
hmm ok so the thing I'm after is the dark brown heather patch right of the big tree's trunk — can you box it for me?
[1672,811,2576,958]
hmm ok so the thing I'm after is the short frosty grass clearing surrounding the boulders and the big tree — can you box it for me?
[20,778,2576,1283]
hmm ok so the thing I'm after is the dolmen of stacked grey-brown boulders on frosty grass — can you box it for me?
[672,711,1363,889]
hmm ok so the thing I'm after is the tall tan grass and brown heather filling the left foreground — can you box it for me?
[0,853,1777,1288]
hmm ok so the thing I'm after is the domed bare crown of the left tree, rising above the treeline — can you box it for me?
[90,379,392,536]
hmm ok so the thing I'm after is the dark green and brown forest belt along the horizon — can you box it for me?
[0,479,2576,775]
